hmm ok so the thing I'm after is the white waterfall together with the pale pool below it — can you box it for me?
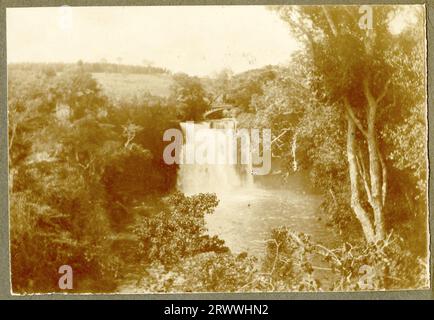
[178,118,330,256]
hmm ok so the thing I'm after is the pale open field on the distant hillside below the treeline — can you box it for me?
[92,72,173,99]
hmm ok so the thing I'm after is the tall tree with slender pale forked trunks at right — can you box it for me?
[274,6,426,243]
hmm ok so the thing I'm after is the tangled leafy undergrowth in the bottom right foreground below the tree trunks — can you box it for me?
[263,227,429,291]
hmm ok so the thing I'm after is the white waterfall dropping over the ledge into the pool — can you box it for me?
[178,118,254,194]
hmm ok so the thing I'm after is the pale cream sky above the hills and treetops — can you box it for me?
[7,6,298,76]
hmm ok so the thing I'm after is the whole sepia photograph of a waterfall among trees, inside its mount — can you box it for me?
[6,4,431,296]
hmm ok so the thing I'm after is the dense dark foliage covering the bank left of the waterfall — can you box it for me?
[8,65,180,291]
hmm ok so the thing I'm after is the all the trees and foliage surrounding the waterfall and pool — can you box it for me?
[8,6,428,292]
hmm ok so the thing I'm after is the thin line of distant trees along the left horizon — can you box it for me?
[8,61,170,74]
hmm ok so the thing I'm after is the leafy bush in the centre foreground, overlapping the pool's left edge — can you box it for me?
[133,192,228,268]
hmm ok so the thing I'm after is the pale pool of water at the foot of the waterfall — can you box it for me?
[206,188,334,256]
